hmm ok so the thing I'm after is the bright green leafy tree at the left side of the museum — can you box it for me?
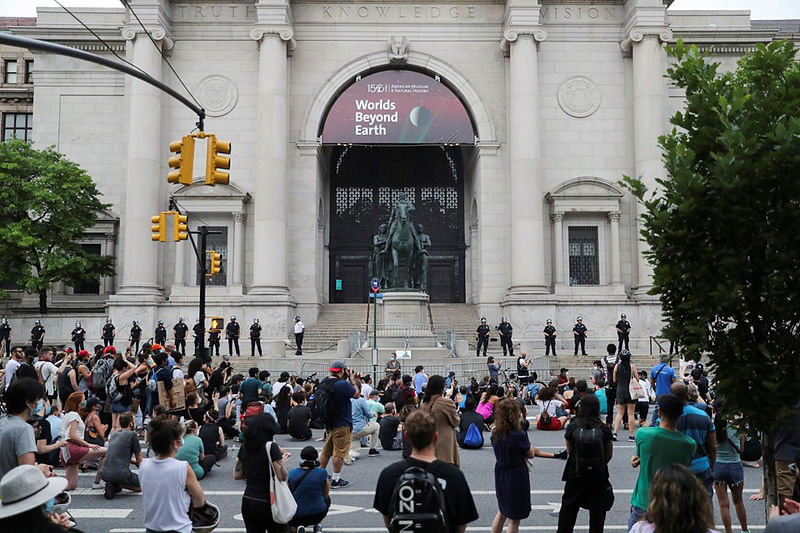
[0,140,114,313]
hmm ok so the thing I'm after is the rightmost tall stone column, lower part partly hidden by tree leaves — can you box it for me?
[620,27,672,296]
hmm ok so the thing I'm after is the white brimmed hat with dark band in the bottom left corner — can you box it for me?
[0,465,67,518]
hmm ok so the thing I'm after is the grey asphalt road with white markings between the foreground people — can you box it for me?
[62,420,764,533]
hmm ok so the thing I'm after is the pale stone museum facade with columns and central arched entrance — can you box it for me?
[4,0,800,351]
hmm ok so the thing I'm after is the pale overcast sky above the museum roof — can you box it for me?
[0,0,800,20]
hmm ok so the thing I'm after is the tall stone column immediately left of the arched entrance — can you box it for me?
[248,27,292,301]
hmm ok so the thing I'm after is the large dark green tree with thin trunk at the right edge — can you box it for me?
[624,42,800,520]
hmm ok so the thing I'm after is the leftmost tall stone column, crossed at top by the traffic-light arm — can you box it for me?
[118,27,167,300]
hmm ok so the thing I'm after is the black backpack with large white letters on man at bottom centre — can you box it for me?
[389,461,449,533]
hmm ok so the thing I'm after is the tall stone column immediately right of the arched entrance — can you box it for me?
[505,29,546,294]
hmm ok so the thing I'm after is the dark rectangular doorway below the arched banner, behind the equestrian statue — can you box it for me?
[330,146,465,303]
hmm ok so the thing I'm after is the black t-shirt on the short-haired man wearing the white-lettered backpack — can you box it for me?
[372,457,478,532]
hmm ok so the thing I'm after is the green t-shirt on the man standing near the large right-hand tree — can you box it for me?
[631,427,697,509]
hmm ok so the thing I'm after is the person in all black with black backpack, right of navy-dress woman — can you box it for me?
[558,394,614,533]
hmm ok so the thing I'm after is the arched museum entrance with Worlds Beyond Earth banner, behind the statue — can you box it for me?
[321,69,475,302]
